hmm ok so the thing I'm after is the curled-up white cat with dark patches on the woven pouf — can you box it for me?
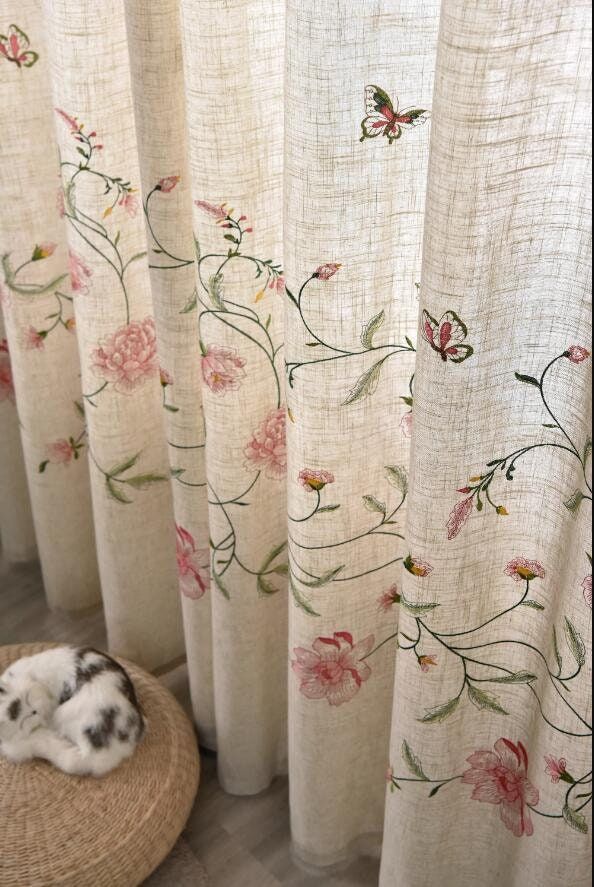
[0,647,146,776]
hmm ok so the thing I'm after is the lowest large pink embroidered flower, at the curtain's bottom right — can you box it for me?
[462,738,540,838]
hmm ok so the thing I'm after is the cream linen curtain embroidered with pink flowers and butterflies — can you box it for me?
[0,0,592,887]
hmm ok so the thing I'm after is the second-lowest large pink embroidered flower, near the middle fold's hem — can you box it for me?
[291,631,374,705]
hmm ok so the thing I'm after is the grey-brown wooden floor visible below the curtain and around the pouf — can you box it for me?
[0,554,378,887]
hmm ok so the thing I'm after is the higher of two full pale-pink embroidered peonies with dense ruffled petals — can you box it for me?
[92,317,159,393]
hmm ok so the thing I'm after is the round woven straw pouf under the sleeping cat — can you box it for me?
[0,644,199,887]
